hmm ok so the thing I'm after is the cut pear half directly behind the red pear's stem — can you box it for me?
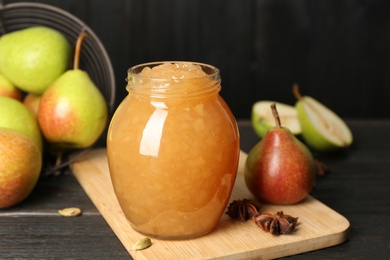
[251,100,301,137]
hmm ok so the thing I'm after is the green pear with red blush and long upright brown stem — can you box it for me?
[38,34,108,148]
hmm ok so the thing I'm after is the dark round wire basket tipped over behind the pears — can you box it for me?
[0,1,115,175]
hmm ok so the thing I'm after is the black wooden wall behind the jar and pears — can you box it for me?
[3,0,390,119]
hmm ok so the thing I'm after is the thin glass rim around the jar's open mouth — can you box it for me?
[127,61,220,81]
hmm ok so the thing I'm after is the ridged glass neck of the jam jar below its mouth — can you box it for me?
[126,62,221,99]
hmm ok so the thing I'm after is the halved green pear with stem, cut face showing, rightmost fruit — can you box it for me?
[293,85,353,152]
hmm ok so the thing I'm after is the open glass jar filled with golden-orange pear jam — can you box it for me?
[107,62,240,239]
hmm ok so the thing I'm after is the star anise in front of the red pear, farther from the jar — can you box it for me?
[252,211,298,235]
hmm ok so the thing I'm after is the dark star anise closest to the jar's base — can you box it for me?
[226,199,261,221]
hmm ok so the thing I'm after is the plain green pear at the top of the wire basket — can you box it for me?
[0,26,71,94]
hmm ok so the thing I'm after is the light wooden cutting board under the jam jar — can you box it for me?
[71,149,349,259]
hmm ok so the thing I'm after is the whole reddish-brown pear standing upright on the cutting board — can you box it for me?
[244,104,316,204]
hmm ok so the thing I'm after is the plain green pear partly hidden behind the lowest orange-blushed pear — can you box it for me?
[0,97,43,151]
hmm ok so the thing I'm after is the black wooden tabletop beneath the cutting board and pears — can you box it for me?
[0,120,390,259]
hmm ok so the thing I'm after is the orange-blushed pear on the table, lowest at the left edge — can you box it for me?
[0,128,42,208]
